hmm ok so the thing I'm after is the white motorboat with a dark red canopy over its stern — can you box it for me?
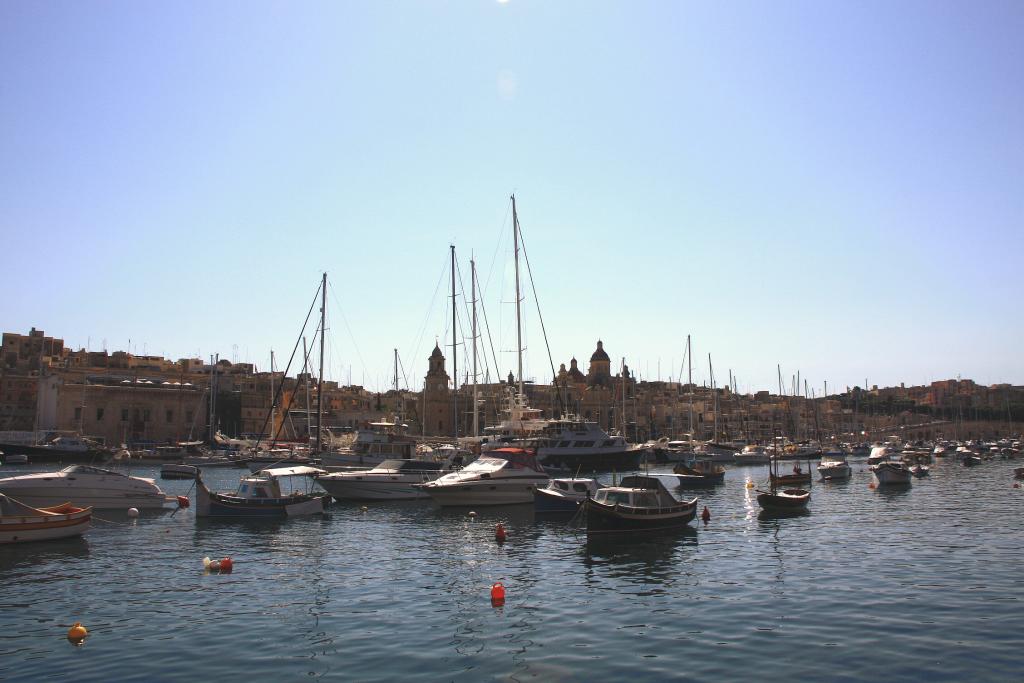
[420,447,549,506]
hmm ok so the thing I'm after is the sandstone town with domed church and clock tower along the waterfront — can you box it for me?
[0,329,1024,445]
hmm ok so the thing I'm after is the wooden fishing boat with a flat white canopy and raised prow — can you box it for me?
[196,467,331,519]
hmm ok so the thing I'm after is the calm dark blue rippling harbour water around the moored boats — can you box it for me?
[0,461,1024,681]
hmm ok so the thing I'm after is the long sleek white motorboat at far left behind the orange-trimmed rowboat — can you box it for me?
[0,465,176,509]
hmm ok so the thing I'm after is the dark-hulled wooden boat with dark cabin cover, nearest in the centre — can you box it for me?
[584,475,697,537]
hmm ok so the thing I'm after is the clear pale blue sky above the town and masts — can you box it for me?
[0,0,1024,394]
